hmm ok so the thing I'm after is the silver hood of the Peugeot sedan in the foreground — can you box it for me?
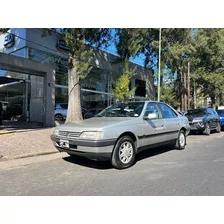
[57,117,138,132]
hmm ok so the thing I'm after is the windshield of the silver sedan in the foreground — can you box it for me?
[96,102,145,117]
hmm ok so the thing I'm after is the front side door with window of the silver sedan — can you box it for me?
[142,102,166,146]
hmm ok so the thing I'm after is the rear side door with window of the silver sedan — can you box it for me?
[159,103,180,141]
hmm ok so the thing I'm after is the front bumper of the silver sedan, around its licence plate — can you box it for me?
[51,135,116,160]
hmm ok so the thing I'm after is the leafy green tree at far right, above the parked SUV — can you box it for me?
[193,29,224,107]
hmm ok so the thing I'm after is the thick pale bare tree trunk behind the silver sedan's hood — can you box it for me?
[65,56,83,123]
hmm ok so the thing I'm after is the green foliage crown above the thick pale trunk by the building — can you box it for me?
[43,28,111,79]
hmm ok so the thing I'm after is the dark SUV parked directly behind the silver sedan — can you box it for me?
[185,108,221,135]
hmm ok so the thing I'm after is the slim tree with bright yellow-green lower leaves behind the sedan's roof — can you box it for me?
[113,28,142,101]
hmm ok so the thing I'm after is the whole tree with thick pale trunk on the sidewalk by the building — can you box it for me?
[44,28,111,123]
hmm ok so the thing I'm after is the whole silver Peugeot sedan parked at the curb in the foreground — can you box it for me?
[51,101,190,169]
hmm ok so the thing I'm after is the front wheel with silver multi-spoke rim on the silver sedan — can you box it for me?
[111,136,136,169]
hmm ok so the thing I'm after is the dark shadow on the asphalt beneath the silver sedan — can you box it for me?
[63,145,175,170]
